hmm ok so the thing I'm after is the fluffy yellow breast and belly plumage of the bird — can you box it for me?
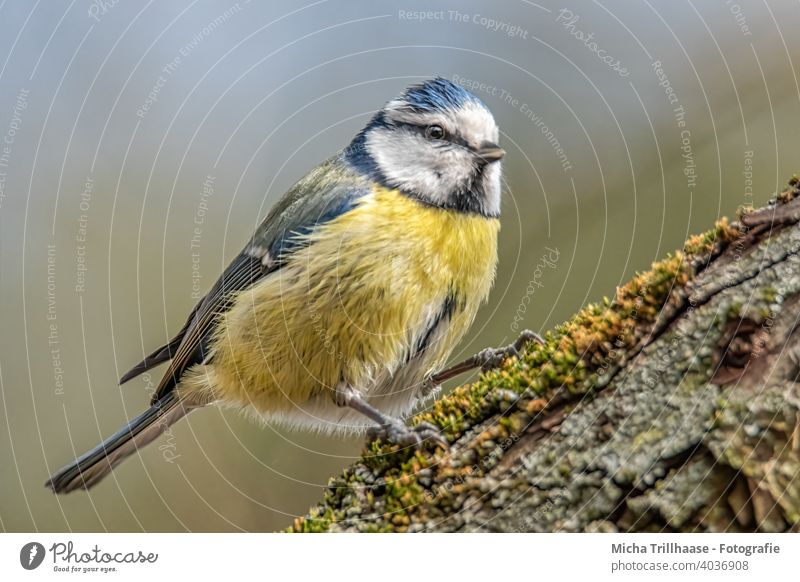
[183,188,499,428]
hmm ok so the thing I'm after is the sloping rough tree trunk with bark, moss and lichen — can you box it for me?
[292,179,800,532]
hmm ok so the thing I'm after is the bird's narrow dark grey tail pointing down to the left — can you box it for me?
[45,391,196,493]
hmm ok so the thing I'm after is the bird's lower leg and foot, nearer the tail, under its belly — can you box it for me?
[335,385,449,448]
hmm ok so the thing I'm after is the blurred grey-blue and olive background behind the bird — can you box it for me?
[0,0,800,531]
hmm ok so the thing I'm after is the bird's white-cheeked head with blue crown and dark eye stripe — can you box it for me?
[345,77,505,216]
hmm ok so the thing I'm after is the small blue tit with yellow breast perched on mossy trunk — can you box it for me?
[45,77,541,493]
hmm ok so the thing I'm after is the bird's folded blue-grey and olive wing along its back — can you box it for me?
[146,156,370,402]
